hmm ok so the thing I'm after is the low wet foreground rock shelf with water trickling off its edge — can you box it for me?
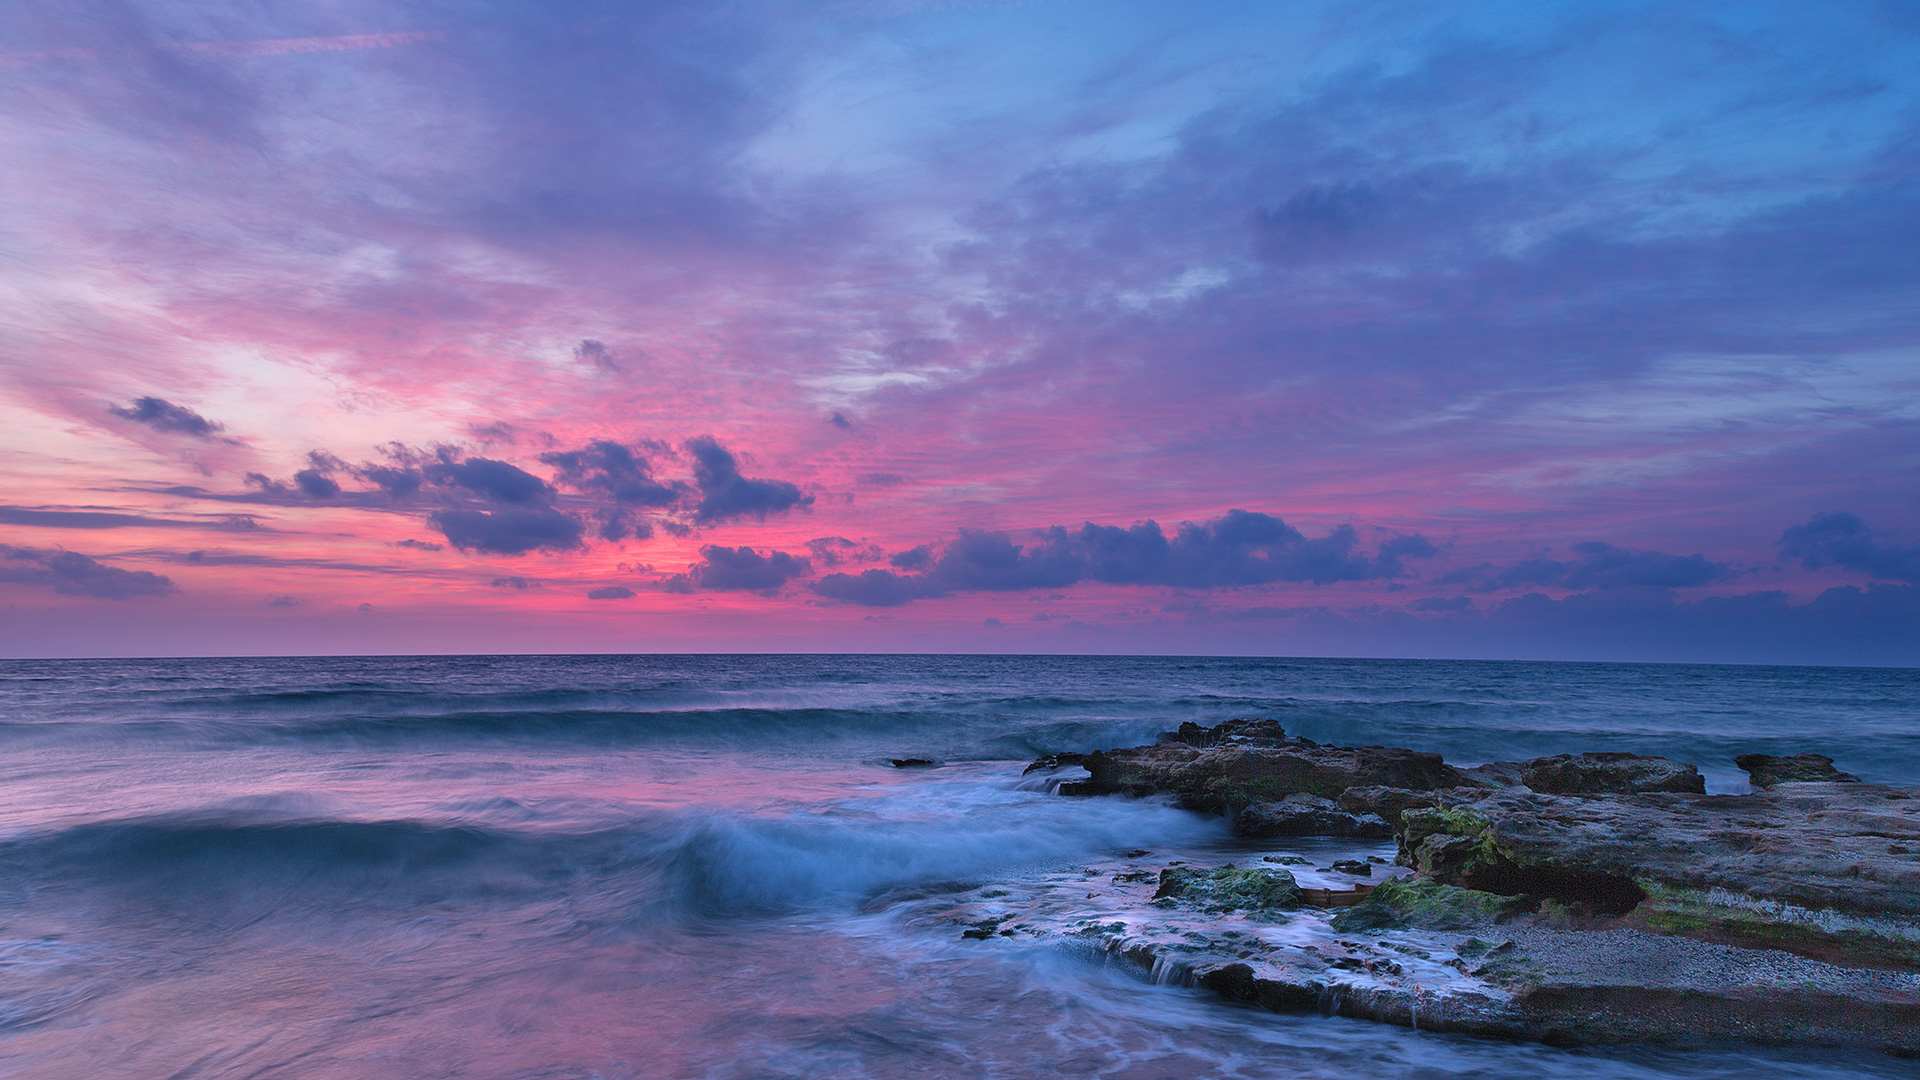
[940,845,1920,1055]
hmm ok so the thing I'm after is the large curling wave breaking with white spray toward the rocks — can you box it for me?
[0,788,1225,924]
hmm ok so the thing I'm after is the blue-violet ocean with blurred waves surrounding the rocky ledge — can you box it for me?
[0,655,1920,1080]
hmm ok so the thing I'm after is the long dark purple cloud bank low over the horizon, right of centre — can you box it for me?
[814,509,1434,605]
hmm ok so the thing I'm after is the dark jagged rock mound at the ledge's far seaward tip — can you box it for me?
[1067,721,1465,813]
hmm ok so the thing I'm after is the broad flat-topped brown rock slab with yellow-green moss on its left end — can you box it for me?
[1396,782,1920,967]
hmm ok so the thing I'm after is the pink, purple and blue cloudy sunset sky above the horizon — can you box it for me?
[0,0,1920,665]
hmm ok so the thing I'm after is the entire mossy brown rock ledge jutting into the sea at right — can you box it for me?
[1002,719,1920,1057]
